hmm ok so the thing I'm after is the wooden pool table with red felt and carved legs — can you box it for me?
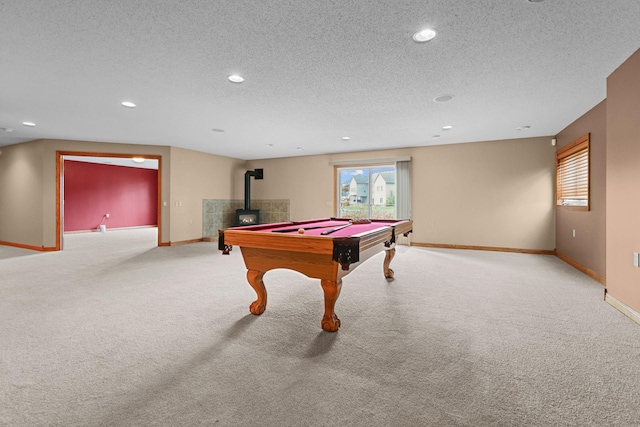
[218,218,413,332]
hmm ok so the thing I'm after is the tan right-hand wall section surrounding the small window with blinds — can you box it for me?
[556,101,607,278]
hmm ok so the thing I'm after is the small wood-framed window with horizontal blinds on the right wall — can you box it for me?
[556,134,590,211]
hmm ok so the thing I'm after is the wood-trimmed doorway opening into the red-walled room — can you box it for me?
[56,151,162,250]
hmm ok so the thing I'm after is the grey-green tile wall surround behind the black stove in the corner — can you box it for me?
[202,199,290,239]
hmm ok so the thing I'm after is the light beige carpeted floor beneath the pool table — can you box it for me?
[0,229,640,426]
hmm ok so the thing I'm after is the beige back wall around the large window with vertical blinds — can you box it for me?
[248,137,555,250]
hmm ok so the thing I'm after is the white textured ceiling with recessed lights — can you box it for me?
[0,0,640,159]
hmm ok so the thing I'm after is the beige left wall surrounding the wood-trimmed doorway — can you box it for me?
[0,140,245,249]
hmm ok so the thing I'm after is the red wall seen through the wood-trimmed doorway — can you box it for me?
[64,160,158,231]
